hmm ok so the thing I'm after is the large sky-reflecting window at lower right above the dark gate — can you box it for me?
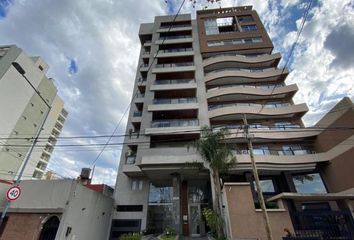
[293,173,327,193]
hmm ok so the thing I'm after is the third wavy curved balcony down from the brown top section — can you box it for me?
[207,84,298,102]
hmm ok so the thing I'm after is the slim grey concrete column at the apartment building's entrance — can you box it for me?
[172,173,182,234]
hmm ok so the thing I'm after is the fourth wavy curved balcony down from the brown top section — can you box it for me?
[209,103,308,120]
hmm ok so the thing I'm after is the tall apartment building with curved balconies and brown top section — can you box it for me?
[111,6,354,239]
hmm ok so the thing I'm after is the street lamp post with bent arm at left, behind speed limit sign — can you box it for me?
[0,62,52,227]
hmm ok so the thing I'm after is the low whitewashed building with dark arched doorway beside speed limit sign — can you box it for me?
[0,180,114,240]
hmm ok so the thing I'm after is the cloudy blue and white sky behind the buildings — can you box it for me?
[0,0,354,186]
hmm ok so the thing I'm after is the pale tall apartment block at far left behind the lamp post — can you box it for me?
[0,45,68,180]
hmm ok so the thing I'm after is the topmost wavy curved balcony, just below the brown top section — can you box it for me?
[203,53,281,71]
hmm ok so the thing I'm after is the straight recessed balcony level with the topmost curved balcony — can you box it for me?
[152,56,195,73]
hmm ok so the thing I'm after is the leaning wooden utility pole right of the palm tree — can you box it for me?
[243,114,273,240]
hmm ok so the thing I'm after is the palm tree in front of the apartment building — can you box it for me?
[195,126,236,237]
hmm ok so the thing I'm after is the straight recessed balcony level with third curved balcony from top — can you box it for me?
[148,89,199,111]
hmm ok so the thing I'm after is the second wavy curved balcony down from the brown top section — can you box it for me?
[204,68,289,86]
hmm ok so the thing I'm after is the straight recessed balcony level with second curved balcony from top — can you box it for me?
[150,72,197,91]
